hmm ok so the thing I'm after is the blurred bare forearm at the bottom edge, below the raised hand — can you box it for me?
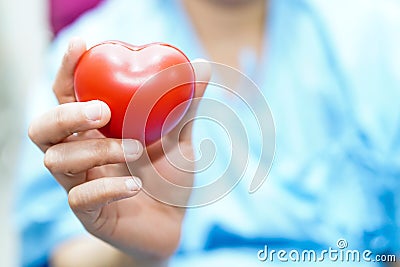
[50,234,168,267]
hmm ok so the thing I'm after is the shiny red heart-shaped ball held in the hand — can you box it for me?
[74,41,195,145]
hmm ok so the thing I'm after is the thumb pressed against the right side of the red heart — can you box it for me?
[176,59,212,141]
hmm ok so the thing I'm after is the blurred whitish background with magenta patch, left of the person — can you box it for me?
[0,0,101,267]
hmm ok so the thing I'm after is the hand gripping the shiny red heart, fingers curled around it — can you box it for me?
[29,39,210,258]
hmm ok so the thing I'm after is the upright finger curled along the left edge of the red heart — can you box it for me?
[53,37,86,104]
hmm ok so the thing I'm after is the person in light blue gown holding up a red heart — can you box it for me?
[16,0,400,266]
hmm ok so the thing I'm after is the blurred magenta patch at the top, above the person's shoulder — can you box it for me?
[50,0,103,35]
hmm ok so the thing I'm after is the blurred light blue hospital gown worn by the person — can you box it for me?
[16,0,400,267]
